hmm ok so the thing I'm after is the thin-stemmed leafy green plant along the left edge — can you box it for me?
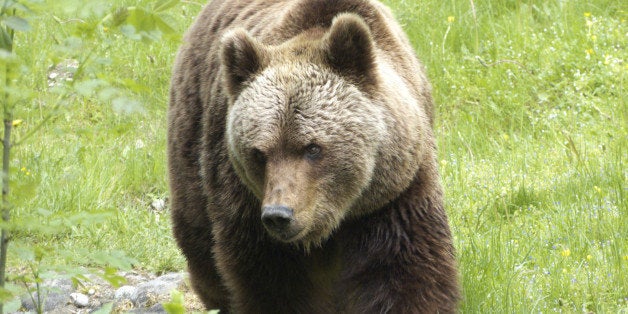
[0,0,180,313]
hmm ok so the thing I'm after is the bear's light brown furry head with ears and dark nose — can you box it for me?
[221,14,387,247]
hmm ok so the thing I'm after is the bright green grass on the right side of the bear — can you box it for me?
[390,1,628,313]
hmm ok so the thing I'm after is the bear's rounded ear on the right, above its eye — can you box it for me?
[323,13,376,87]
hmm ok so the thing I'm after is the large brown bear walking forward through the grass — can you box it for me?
[168,0,459,313]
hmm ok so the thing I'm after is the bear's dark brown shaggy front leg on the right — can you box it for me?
[341,179,459,313]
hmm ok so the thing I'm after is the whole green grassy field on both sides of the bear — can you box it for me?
[10,0,628,313]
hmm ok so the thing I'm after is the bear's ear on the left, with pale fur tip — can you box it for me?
[221,29,266,96]
